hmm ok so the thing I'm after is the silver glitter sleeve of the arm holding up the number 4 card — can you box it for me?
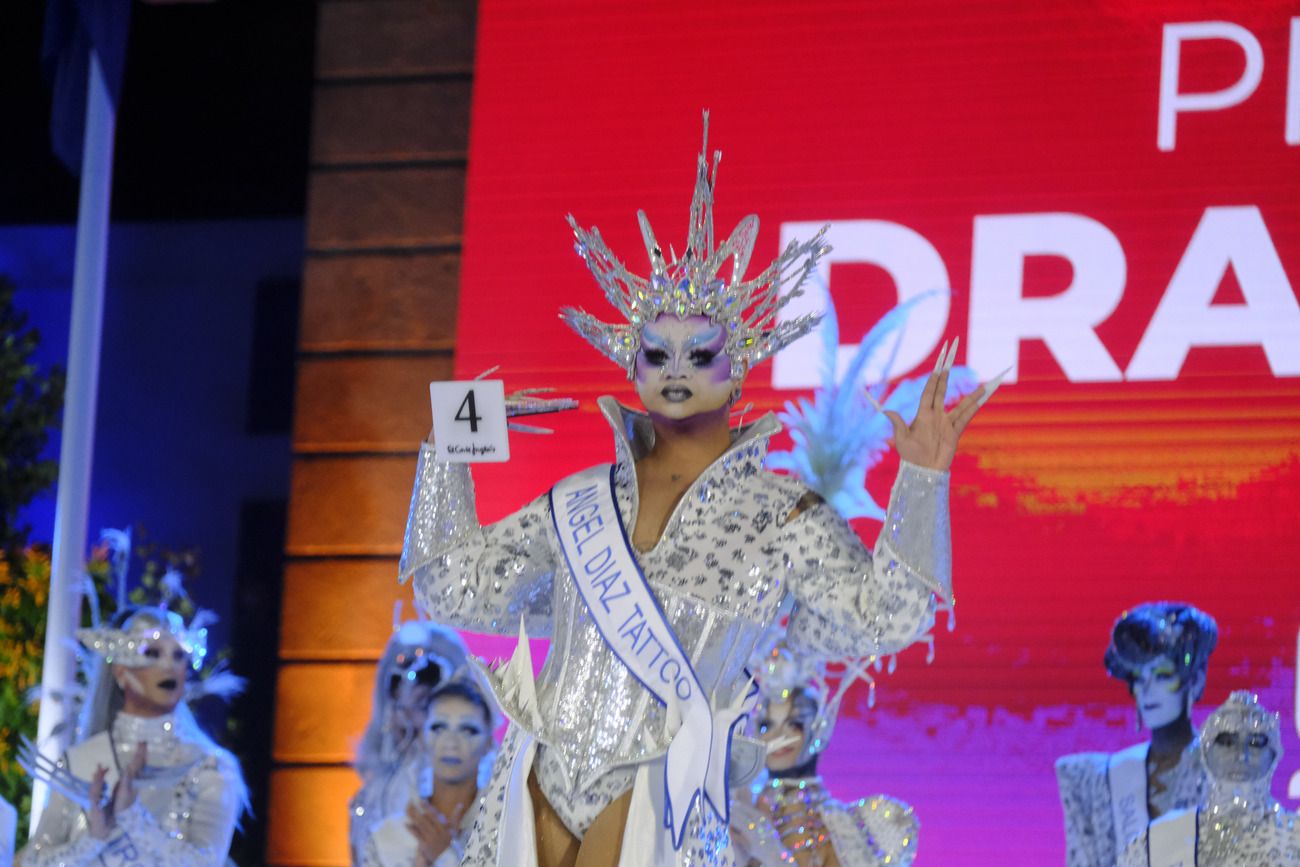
[398,443,555,638]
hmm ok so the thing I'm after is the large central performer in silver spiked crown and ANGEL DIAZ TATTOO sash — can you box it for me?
[400,115,983,867]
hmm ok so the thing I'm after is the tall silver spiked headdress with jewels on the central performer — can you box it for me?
[560,112,831,378]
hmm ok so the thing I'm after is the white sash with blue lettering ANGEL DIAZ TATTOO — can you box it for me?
[551,464,744,849]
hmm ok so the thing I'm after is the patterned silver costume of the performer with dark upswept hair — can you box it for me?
[1056,740,1205,867]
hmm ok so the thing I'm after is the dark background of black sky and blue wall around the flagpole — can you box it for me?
[0,0,315,864]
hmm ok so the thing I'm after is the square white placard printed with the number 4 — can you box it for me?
[429,380,510,464]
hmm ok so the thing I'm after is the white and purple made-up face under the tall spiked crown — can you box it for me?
[634,313,736,420]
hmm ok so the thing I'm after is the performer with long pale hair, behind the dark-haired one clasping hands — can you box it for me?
[348,620,468,863]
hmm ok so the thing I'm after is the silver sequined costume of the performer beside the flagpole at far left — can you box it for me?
[16,711,243,867]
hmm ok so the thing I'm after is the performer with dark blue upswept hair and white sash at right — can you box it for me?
[1057,602,1218,867]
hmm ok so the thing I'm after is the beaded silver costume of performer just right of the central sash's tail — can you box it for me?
[732,777,920,867]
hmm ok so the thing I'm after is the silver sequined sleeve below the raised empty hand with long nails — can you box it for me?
[784,463,952,658]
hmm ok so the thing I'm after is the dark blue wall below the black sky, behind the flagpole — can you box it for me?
[0,220,303,657]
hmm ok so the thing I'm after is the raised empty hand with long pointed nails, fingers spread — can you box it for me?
[868,338,1009,471]
